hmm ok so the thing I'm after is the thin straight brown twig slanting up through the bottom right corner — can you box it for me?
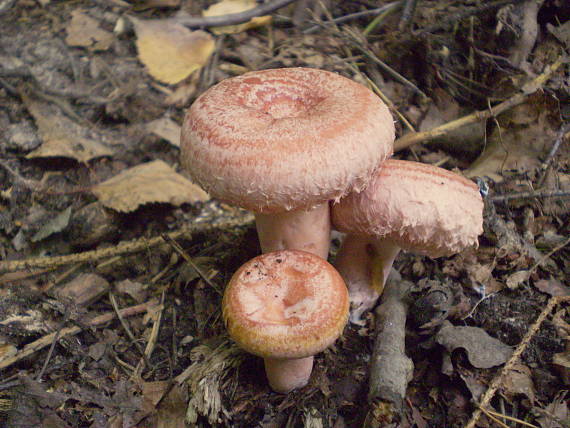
[465,296,570,428]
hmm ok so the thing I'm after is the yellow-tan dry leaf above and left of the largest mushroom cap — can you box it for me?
[131,18,215,85]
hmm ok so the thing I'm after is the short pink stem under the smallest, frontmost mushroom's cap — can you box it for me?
[263,356,313,394]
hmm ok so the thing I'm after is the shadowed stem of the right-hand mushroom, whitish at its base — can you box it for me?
[335,234,400,325]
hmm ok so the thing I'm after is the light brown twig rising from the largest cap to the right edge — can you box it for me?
[394,57,564,152]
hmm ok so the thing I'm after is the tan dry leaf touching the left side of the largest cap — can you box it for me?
[93,160,209,212]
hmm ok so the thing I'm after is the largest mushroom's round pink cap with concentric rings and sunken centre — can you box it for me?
[181,68,394,213]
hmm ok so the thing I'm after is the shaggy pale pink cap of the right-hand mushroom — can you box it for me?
[332,159,483,257]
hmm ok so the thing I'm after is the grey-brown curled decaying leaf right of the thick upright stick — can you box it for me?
[435,321,513,369]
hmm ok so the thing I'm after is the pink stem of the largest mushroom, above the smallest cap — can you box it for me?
[255,203,331,260]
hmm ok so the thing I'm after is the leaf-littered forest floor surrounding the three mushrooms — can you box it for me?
[0,0,570,428]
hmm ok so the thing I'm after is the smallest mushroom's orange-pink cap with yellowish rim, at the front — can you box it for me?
[222,250,349,359]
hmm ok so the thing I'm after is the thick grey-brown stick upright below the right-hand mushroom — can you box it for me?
[368,280,414,413]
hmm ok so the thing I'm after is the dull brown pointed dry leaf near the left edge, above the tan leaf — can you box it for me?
[20,93,113,163]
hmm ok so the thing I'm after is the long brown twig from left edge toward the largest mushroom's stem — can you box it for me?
[0,211,253,273]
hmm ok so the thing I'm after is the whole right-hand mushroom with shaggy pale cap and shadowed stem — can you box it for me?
[332,159,483,324]
